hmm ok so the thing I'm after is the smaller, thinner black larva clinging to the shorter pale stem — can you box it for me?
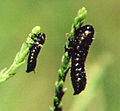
[26,33,46,73]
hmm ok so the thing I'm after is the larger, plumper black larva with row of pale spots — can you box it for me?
[68,25,94,95]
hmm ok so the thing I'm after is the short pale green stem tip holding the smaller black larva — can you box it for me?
[0,26,40,83]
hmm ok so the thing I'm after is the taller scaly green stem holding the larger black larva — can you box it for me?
[50,7,87,111]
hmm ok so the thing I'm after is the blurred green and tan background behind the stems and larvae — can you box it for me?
[0,0,120,111]
